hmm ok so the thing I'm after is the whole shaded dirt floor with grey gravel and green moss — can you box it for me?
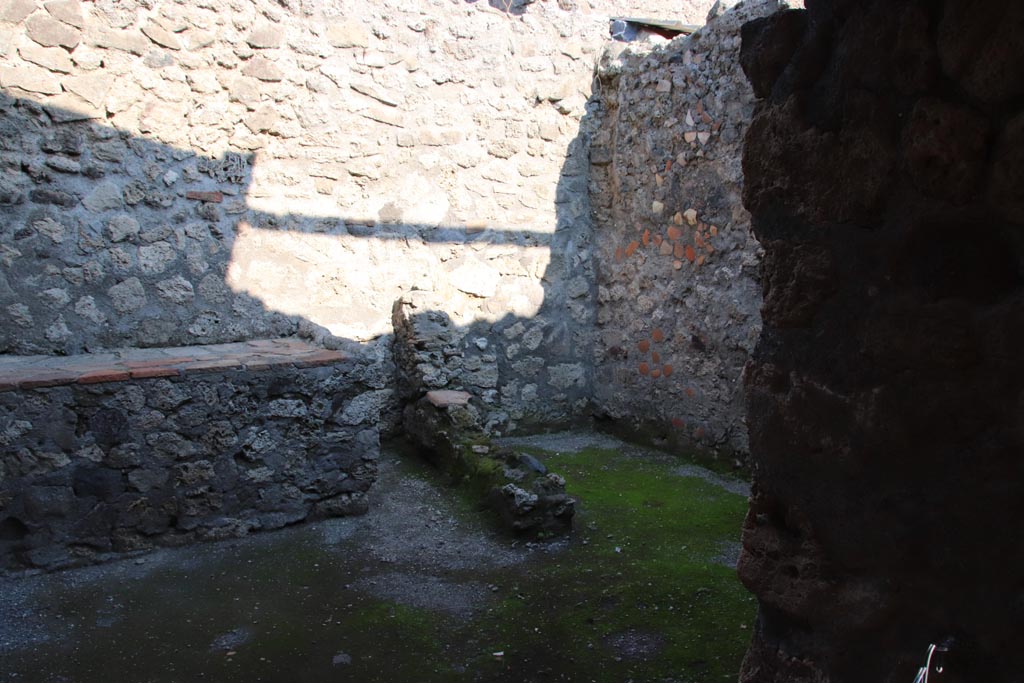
[0,432,755,682]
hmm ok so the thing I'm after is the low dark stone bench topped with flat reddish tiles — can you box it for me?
[0,338,390,570]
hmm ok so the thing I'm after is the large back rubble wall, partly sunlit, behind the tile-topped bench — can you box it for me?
[0,0,710,432]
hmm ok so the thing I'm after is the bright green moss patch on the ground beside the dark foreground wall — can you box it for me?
[460,450,756,681]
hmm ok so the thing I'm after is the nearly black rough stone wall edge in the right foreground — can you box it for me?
[739,0,1024,683]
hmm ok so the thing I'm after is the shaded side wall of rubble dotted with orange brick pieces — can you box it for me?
[590,0,782,457]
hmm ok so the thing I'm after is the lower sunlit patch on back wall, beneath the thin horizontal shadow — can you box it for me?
[226,222,550,341]
